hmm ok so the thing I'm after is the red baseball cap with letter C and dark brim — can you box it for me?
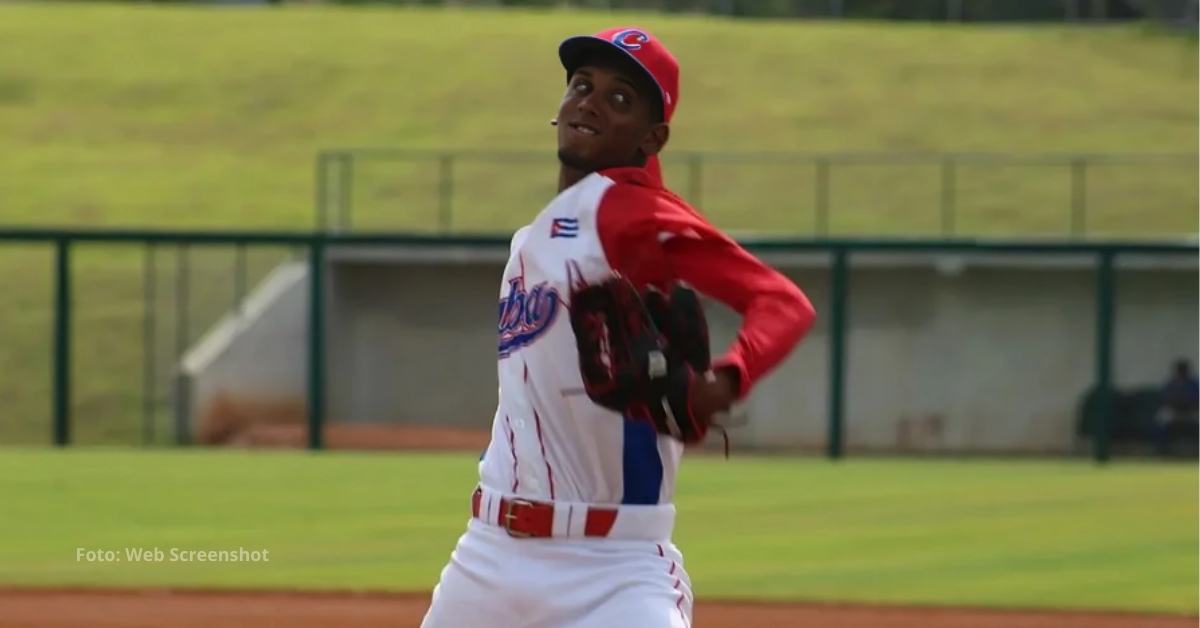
[558,26,679,122]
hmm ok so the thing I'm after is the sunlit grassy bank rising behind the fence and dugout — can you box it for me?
[0,2,1198,444]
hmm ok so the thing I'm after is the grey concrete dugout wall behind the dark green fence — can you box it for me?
[180,247,1200,451]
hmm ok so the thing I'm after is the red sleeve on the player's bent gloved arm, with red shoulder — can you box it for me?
[596,185,816,397]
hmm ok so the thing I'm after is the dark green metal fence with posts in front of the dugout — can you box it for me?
[0,228,1198,461]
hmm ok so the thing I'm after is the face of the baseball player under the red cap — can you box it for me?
[557,65,667,172]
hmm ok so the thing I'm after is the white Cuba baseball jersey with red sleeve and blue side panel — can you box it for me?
[480,168,814,504]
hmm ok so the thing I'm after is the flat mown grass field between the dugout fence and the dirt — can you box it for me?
[0,449,1198,614]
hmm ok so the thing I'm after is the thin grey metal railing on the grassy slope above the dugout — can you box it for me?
[314,149,1200,238]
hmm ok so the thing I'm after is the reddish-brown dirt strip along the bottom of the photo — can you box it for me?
[0,590,1196,628]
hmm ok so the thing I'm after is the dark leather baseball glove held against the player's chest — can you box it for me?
[571,275,709,443]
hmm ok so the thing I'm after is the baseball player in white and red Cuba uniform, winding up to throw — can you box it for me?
[422,28,815,628]
